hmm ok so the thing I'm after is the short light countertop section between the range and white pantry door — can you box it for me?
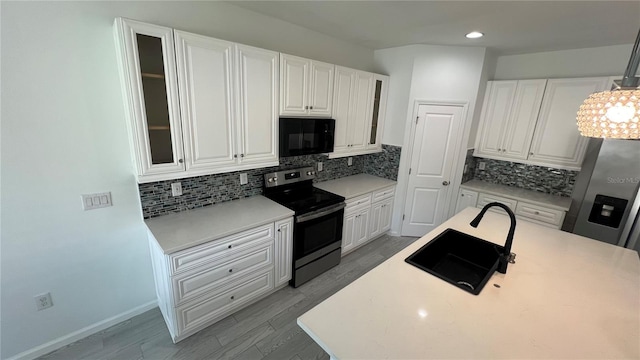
[313,174,396,199]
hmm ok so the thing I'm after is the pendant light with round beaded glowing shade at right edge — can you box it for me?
[576,31,640,139]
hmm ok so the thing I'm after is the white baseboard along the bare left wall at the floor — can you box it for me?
[7,300,158,360]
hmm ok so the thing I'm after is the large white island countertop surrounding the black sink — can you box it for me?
[298,207,640,359]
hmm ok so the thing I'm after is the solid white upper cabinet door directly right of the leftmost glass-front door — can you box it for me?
[175,30,237,171]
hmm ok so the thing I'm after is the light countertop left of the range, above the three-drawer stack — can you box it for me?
[145,196,293,254]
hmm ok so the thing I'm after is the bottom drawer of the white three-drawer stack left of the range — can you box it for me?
[176,269,274,336]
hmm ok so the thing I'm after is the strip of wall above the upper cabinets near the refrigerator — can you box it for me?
[493,44,633,80]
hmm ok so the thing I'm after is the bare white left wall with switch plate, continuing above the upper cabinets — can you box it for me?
[0,1,373,359]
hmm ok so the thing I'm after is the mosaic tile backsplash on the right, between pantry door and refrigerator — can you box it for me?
[469,158,578,197]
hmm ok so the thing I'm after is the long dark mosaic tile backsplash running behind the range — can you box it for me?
[138,145,401,219]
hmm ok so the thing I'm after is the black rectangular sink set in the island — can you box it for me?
[405,229,504,295]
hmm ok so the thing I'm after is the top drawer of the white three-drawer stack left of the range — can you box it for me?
[169,223,274,275]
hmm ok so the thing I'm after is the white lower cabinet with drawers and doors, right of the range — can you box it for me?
[342,186,395,255]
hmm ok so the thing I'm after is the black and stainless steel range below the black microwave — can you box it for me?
[264,167,345,287]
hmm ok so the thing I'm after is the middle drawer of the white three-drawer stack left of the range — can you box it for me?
[172,239,273,305]
